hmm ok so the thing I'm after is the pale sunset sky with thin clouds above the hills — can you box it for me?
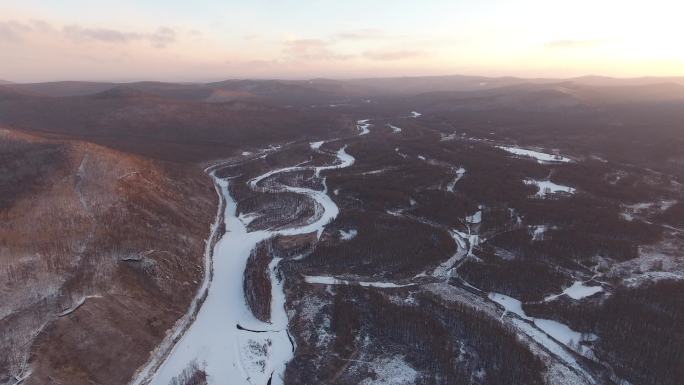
[0,0,684,82]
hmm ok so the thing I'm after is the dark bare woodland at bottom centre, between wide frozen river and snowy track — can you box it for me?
[322,287,543,385]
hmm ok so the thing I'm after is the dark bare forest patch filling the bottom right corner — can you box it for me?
[525,281,684,385]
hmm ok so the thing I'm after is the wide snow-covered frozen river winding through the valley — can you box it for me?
[141,136,358,385]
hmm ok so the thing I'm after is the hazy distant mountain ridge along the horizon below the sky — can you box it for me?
[8,75,684,101]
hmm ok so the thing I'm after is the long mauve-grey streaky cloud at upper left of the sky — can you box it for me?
[62,25,176,48]
